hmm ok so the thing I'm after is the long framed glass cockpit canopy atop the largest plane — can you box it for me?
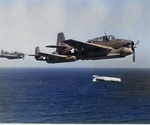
[87,35,115,43]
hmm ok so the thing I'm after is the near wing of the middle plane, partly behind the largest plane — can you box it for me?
[37,52,67,59]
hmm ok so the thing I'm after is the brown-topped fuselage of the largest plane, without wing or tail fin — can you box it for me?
[65,39,133,60]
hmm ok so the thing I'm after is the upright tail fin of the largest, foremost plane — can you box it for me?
[56,32,67,53]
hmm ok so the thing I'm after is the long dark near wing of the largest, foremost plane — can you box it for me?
[63,39,112,52]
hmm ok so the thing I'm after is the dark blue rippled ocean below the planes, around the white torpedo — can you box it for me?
[0,68,150,123]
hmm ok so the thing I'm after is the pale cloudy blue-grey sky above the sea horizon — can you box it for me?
[0,0,150,68]
